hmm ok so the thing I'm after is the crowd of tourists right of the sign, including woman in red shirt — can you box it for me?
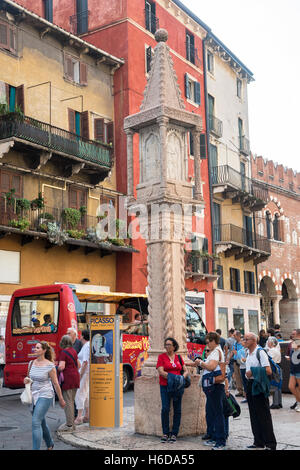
[156,325,300,450]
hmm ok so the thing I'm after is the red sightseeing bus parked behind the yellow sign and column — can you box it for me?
[4,284,207,391]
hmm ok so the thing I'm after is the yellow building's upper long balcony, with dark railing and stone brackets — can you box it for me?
[0,113,112,184]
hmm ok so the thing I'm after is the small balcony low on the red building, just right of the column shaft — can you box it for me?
[185,250,218,282]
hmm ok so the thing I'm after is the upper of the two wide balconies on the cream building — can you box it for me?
[211,165,269,212]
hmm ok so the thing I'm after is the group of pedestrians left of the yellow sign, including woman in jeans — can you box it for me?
[24,328,90,450]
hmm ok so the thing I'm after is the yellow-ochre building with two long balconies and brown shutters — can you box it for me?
[0,3,132,328]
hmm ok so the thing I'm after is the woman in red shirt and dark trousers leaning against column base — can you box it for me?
[156,338,188,443]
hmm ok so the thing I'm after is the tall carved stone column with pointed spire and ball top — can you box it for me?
[124,29,206,436]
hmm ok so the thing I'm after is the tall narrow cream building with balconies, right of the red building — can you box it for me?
[205,33,270,335]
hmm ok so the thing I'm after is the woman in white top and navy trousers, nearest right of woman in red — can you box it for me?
[195,332,226,450]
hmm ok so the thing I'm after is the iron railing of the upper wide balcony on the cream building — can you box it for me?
[211,165,269,210]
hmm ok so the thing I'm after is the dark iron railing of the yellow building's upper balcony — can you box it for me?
[0,113,112,169]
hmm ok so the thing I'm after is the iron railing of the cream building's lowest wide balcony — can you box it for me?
[214,224,271,254]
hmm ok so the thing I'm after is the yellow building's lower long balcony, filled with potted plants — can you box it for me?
[0,204,137,257]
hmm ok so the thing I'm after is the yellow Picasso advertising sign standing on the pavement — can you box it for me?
[90,315,123,427]
